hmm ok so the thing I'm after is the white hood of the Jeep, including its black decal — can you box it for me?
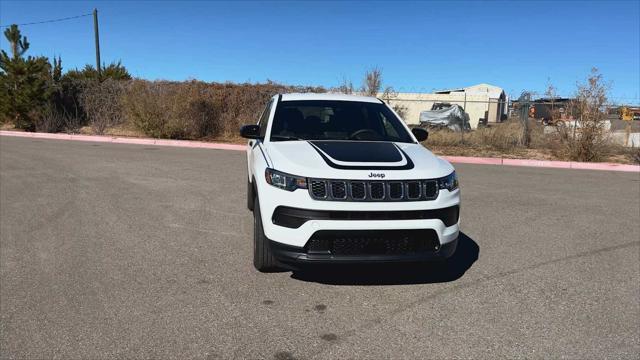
[265,140,453,180]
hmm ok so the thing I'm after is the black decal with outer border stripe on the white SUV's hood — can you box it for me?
[309,141,414,170]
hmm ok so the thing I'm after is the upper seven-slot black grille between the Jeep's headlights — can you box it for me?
[309,179,438,201]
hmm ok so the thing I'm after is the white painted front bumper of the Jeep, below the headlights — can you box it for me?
[255,179,460,250]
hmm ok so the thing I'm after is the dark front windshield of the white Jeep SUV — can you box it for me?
[271,100,413,143]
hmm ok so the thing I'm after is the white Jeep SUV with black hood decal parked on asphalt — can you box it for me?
[240,94,460,271]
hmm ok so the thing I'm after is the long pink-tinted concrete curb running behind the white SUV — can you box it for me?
[0,130,640,173]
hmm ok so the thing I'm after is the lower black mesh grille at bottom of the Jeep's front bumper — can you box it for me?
[305,229,439,256]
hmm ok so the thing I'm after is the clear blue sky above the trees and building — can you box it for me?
[0,0,640,103]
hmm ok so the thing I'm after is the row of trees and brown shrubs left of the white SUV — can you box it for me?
[0,25,402,139]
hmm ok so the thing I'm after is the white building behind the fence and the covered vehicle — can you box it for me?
[379,84,507,129]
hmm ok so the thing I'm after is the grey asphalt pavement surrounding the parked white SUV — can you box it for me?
[0,137,640,360]
